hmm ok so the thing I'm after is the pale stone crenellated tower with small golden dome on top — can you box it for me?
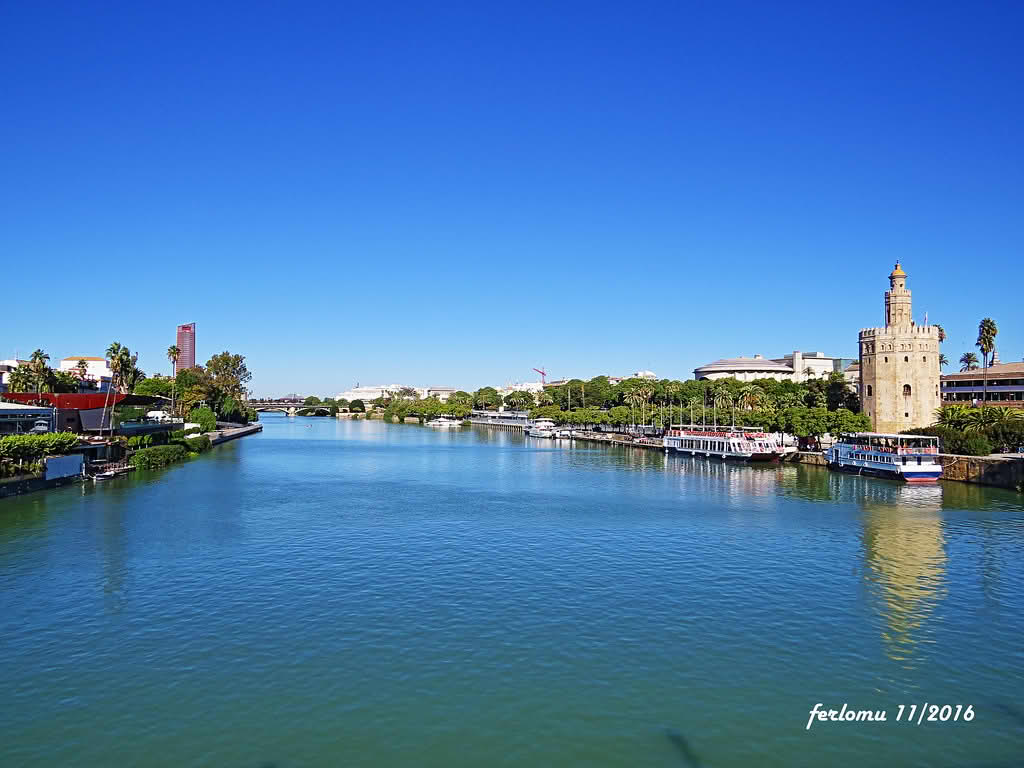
[860,262,940,432]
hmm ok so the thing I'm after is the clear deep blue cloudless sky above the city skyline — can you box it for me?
[0,2,1024,394]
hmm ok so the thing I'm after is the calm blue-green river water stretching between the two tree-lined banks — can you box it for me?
[0,415,1024,768]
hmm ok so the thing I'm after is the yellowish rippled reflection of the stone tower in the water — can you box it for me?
[859,481,947,667]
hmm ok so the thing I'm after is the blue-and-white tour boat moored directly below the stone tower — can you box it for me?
[824,432,942,482]
